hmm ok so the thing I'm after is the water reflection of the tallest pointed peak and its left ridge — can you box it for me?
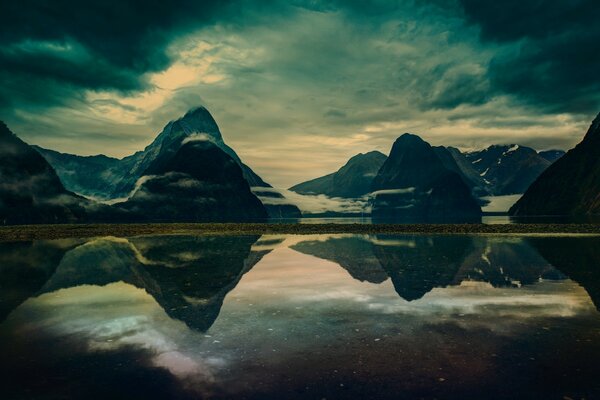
[32,236,268,331]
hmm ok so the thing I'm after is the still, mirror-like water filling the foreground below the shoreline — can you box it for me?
[0,235,600,399]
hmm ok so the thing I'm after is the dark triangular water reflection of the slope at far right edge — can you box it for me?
[527,237,600,310]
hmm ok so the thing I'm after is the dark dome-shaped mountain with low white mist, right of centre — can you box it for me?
[371,133,481,220]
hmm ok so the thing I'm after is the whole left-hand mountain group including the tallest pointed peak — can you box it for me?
[0,107,290,224]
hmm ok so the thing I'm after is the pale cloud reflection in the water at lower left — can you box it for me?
[12,282,220,388]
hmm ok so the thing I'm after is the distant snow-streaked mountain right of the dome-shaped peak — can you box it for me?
[465,144,551,196]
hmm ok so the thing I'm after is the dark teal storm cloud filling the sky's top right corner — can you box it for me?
[461,0,600,113]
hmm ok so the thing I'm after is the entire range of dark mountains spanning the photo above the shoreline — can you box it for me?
[0,107,600,224]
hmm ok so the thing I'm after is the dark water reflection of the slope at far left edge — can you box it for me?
[0,240,77,321]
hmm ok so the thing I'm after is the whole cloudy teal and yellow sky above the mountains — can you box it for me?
[0,0,600,187]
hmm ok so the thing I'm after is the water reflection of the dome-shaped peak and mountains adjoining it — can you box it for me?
[292,235,565,301]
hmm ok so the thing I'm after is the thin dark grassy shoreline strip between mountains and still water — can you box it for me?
[0,223,600,242]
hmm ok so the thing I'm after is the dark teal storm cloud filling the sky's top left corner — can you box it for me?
[0,0,228,105]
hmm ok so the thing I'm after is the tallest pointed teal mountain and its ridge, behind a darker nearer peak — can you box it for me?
[37,107,300,217]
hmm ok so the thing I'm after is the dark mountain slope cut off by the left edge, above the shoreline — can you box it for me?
[0,121,91,224]
